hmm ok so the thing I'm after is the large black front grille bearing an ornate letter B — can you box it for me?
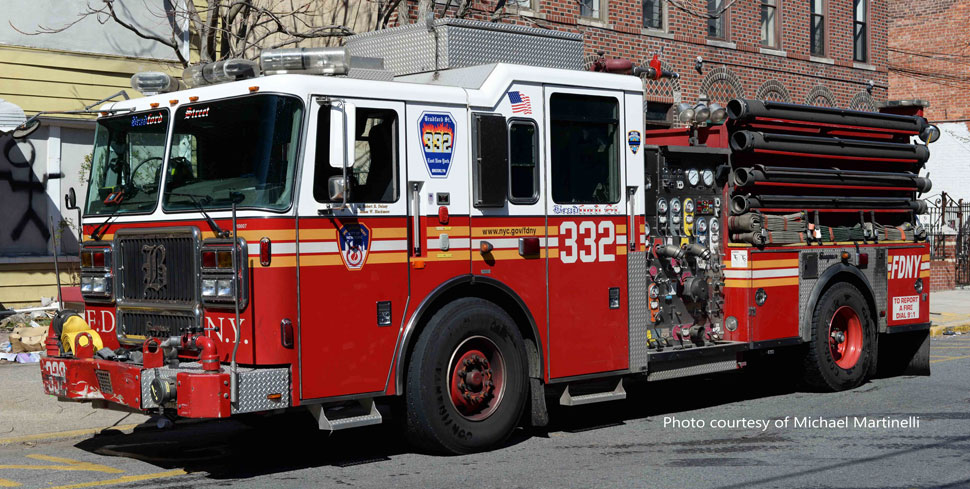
[115,233,199,304]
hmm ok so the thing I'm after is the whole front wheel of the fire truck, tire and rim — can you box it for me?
[406,298,528,453]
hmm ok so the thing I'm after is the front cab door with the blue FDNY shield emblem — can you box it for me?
[297,97,408,399]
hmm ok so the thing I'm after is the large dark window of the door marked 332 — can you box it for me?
[549,93,620,204]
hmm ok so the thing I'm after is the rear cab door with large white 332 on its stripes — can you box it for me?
[544,86,629,378]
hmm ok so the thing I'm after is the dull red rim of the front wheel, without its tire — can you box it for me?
[447,336,505,421]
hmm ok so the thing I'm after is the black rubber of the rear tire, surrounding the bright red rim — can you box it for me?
[802,282,876,391]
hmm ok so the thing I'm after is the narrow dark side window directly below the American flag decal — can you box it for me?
[509,120,539,204]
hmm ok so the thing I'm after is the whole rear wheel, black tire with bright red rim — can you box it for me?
[803,282,876,391]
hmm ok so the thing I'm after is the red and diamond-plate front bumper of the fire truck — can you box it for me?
[40,357,291,418]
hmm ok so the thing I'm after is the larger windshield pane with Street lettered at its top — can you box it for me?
[162,95,303,210]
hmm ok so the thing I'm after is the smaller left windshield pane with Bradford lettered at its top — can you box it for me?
[85,110,168,215]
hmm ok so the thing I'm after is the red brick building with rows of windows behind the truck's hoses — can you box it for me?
[404,0,887,120]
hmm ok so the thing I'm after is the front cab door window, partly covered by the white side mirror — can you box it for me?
[313,107,398,203]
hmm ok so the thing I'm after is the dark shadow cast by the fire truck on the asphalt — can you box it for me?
[75,360,868,479]
